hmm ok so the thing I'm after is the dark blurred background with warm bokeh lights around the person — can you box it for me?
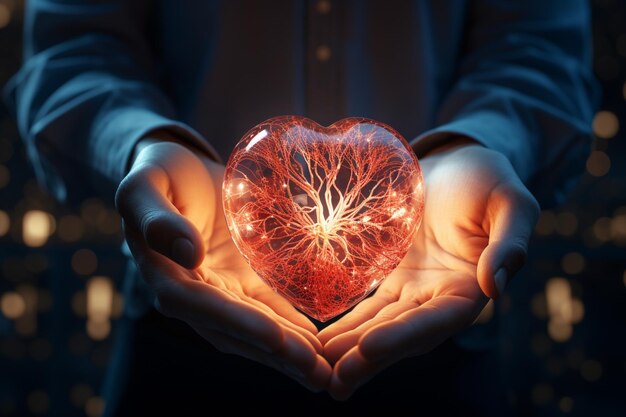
[0,0,626,416]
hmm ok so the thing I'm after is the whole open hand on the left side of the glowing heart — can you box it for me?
[116,139,331,390]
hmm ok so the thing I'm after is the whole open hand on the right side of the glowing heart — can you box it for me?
[318,143,539,399]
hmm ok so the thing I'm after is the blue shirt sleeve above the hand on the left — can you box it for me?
[5,0,219,201]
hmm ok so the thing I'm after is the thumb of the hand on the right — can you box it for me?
[477,182,539,298]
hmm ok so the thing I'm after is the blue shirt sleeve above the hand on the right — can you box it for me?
[412,0,598,206]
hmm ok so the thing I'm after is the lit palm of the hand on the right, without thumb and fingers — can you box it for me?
[360,143,499,324]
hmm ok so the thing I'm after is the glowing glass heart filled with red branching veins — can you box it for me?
[223,116,424,321]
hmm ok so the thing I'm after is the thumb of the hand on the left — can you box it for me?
[115,167,204,269]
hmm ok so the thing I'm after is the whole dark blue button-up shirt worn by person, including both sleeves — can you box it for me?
[6,0,595,204]
